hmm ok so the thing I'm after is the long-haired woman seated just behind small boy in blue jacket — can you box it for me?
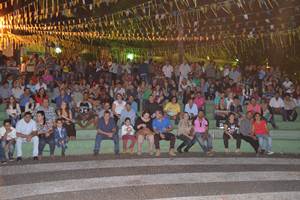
[57,101,76,140]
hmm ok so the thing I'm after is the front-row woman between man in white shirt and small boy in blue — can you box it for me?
[36,111,55,160]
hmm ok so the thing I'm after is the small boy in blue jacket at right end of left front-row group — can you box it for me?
[54,118,68,156]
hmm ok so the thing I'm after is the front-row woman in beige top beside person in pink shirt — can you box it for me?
[177,112,194,153]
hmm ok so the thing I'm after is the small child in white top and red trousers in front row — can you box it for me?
[121,117,136,153]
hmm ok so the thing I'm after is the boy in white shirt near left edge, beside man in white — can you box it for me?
[0,119,17,161]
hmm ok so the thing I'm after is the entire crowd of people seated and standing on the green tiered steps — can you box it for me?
[0,52,300,163]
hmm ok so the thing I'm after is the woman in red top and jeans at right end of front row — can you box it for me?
[252,113,274,155]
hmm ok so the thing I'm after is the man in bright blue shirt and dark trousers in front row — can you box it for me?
[152,110,176,156]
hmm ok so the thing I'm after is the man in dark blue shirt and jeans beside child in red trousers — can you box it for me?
[94,111,119,156]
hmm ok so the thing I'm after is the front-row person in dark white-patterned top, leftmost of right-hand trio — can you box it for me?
[223,113,241,153]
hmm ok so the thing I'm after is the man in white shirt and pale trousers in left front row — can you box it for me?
[16,112,39,161]
